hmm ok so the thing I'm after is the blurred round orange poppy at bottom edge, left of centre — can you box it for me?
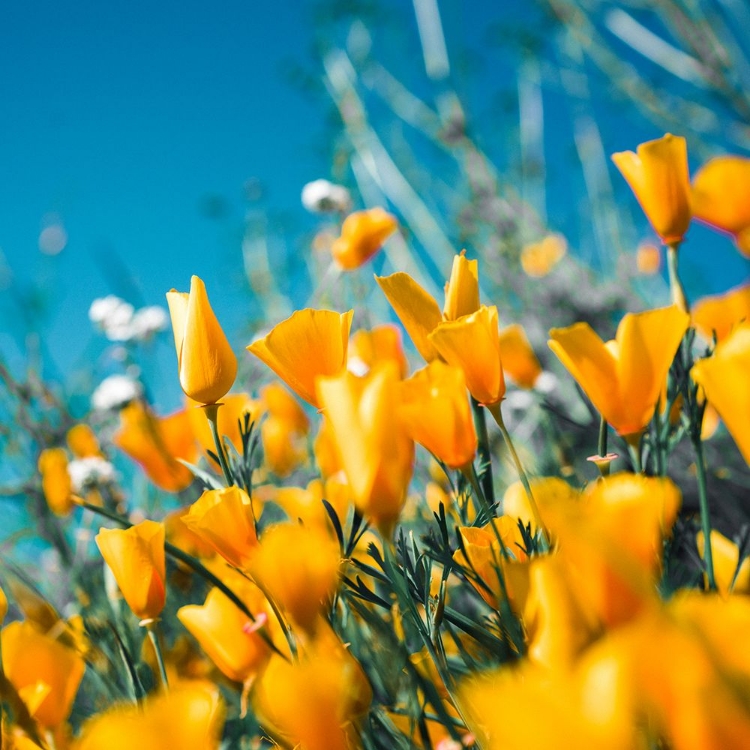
[253,626,372,750]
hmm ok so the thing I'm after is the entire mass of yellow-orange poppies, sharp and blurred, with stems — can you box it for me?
[1,135,750,750]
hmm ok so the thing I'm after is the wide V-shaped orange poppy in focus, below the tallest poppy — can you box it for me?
[549,306,690,435]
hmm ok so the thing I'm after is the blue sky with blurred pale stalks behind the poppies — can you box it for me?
[0,0,750,414]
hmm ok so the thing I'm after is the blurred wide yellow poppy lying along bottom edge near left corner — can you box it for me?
[73,681,224,750]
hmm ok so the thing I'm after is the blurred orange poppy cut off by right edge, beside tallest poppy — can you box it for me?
[693,156,750,256]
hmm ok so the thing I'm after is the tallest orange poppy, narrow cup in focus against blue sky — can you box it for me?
[612,133,691,245]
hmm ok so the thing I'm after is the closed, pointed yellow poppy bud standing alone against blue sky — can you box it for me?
[167,276,237,404]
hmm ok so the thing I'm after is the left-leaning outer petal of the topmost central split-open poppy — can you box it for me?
[375,273,443,362]
